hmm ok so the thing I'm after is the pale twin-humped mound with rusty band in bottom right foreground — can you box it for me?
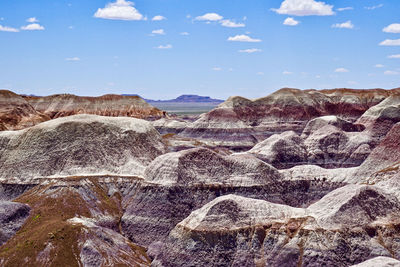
[149,185,400,266]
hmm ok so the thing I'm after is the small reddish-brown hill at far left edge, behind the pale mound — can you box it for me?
[0,90,50,131]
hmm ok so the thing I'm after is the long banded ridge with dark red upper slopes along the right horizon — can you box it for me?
[180,88,400,149]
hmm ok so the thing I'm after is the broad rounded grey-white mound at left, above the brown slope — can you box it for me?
[0,115,165,179]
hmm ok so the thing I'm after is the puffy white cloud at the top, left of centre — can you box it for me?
[94,0,145,20]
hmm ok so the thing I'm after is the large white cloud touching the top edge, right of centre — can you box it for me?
[272,0,335,16]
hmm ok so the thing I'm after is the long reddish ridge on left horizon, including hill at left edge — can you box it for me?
[0,90,166,131]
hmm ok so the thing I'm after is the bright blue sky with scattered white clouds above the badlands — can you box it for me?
[0,0,400,99]
